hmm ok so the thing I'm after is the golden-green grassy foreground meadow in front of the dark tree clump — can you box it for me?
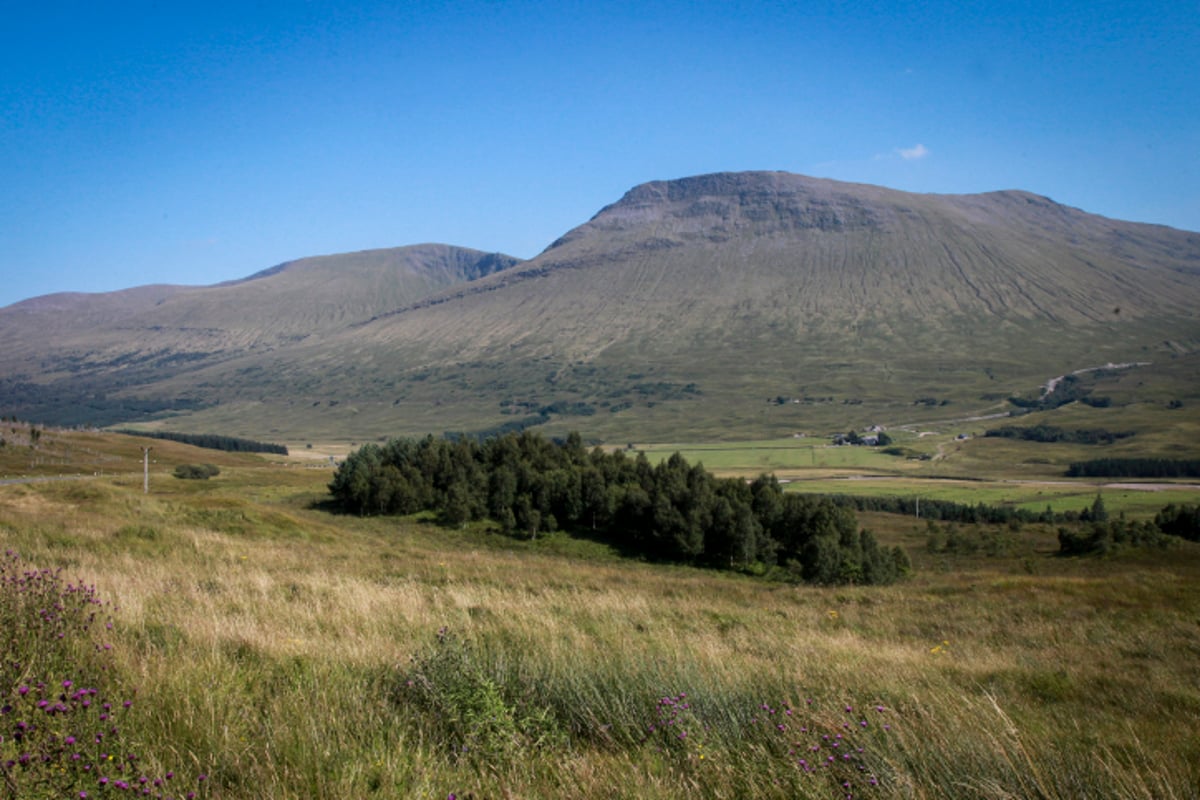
[0,431,1200,799]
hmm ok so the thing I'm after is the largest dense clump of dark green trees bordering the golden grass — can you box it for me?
[329,431,910,584]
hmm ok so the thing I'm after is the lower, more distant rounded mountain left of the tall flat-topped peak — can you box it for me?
[0,245,518,424]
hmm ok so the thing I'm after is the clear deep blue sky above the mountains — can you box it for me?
[0,0,1200,306]
